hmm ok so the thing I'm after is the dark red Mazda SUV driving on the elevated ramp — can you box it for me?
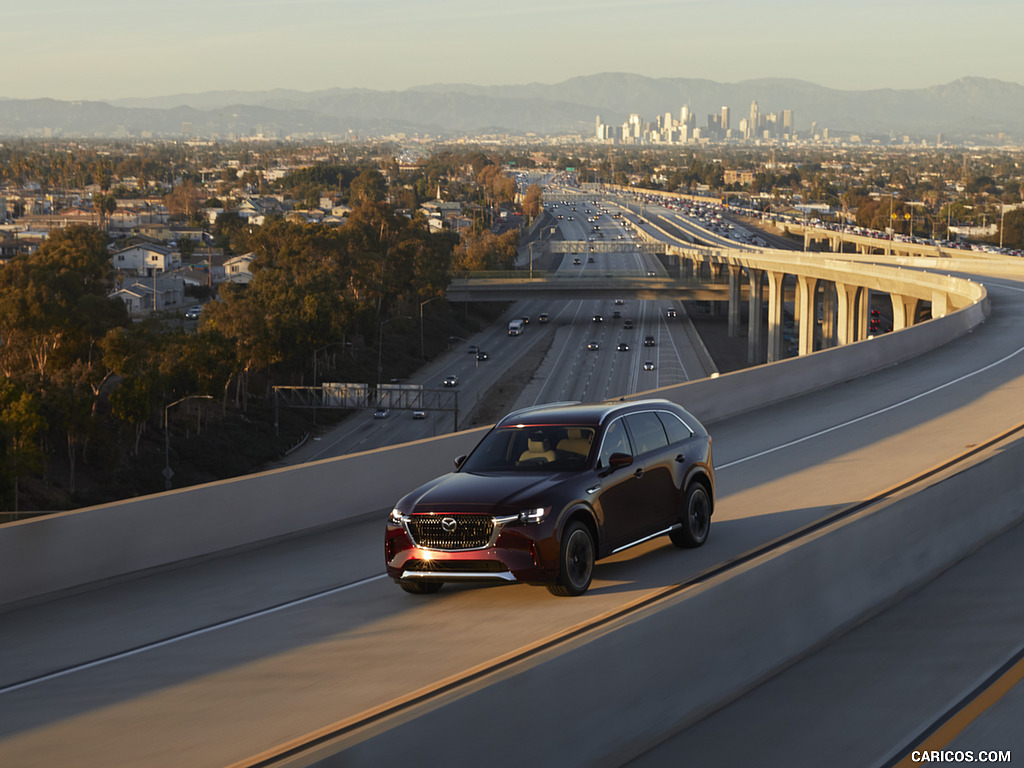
[384,399,715,596]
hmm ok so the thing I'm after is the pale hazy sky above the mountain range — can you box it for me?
[0,0,1024,99]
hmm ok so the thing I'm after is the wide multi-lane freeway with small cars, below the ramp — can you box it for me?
[288,198,717,463]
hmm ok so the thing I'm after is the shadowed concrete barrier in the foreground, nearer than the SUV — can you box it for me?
[339,430,1024,768]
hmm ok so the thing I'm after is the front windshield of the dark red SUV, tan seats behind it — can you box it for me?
[461,424,597,473]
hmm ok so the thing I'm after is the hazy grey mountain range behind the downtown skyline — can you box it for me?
[0,73,1024,141]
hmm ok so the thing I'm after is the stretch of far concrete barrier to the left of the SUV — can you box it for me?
[0,429,485,605]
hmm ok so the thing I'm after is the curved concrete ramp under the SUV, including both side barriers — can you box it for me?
[0,243,1024,766]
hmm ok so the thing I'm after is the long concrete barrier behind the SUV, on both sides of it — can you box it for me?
[0,286,988,605]
